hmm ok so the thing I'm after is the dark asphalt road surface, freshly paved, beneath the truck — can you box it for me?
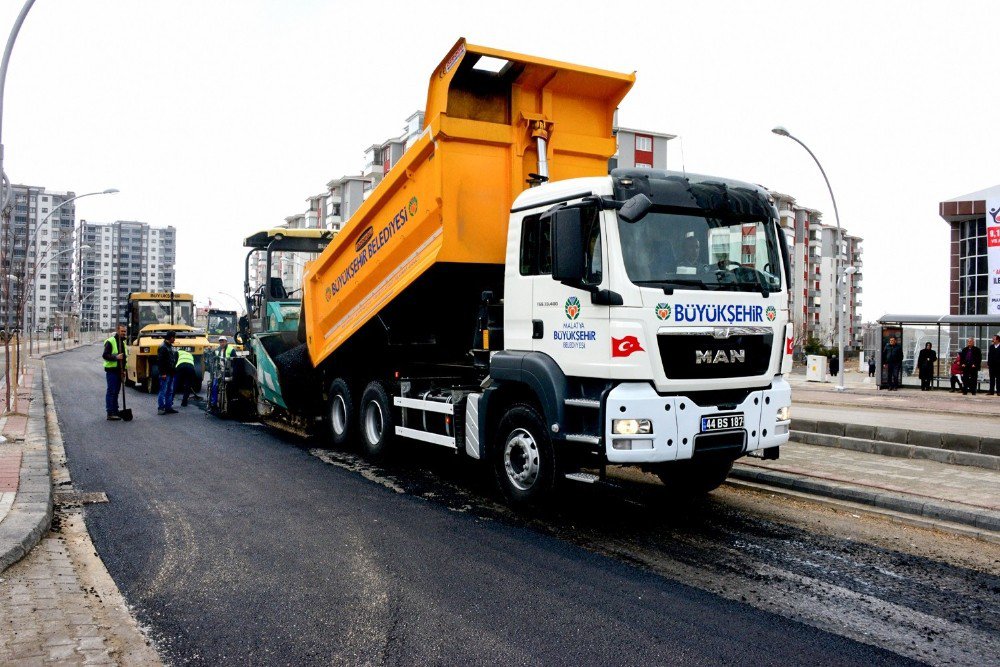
[48,346,1000,665]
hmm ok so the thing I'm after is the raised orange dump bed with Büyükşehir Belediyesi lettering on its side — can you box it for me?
[303,40,635,365]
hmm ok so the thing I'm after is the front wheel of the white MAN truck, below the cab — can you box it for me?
[491,404,556,507]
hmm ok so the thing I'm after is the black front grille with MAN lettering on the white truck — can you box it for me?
[656,333,774,380]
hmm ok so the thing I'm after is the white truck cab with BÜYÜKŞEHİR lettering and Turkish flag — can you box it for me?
[491,169,791,488]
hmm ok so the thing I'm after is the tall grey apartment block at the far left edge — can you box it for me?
[0,185,76,329]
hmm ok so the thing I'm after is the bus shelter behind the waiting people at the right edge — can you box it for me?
[865,314,1000,389]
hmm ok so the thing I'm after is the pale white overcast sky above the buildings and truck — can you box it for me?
[0,0,1000,320]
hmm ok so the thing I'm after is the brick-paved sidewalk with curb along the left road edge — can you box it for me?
[0,342,159,665]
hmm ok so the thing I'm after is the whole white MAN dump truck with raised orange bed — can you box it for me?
[279,40,790,504]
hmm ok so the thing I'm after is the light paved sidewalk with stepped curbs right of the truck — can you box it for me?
[732,373,1000,539]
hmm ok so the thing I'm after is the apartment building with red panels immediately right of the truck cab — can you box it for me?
[771,192,864,353]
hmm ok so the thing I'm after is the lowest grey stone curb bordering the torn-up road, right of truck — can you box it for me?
[730,464,1000,532]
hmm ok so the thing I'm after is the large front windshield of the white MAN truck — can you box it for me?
[618,209,781,292]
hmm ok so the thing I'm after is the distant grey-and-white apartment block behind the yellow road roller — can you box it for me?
[72,220,177,330]
